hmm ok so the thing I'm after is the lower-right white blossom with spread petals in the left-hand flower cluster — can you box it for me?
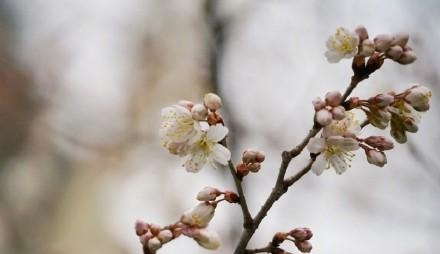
[184,124,231,172]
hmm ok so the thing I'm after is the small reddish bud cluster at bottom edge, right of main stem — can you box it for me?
[271,228,313,253]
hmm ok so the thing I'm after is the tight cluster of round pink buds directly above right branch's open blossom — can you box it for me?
[312,91,345,126]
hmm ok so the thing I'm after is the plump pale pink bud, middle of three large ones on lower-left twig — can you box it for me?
[180,203,215,228]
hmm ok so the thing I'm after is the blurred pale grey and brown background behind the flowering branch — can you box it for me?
[0,0,440,254]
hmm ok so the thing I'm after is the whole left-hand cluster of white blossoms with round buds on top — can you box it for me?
[159,93,231,172]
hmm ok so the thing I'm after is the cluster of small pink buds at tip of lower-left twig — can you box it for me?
[135,220,182,254]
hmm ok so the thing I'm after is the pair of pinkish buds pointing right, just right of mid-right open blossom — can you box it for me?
[358,136,394,167]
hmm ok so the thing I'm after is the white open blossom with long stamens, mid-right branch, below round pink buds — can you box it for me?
[307,113,360,175]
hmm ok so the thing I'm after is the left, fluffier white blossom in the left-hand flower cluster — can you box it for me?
[159,104,197,156]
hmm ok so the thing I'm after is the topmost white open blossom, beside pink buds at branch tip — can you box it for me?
[325,27,359,63]
